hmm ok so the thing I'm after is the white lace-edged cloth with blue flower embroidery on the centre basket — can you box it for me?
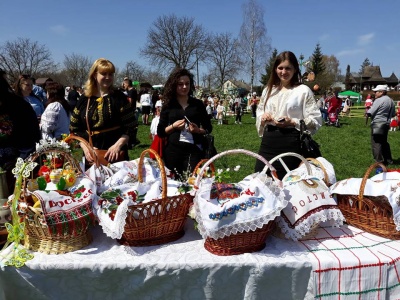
[194,173,287,239]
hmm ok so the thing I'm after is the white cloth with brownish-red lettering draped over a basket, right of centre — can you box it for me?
[277,175,344,240]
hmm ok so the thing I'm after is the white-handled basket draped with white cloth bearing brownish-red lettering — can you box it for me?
[270,152,344,240]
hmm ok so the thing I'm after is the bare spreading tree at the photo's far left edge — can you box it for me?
[0,38,57,82]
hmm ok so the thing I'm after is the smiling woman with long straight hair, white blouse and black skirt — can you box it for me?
[255,51,322,179]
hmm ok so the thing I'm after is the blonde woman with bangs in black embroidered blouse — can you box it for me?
[70,58,135,163]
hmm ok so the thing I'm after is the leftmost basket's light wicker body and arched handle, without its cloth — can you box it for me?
[20,147,94,254]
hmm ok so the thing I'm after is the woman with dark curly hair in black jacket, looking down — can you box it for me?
[157,68,212,177]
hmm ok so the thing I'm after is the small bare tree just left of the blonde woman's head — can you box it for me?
[64,53,92,86]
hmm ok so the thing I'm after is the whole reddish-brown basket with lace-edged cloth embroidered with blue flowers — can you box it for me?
[194,149,287,255]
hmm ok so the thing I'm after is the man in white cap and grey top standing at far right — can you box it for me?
[367,84,396,165]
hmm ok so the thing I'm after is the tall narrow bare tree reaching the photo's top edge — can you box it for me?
[239,0,271,91]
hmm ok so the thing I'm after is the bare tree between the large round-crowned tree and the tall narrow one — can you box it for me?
[207,33,241,88]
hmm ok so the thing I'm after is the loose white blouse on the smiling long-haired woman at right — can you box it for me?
[256,84,322,137]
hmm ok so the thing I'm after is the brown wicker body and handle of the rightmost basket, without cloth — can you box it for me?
[337,163,400,240]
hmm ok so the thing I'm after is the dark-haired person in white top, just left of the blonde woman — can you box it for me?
[40,82,71,140]
